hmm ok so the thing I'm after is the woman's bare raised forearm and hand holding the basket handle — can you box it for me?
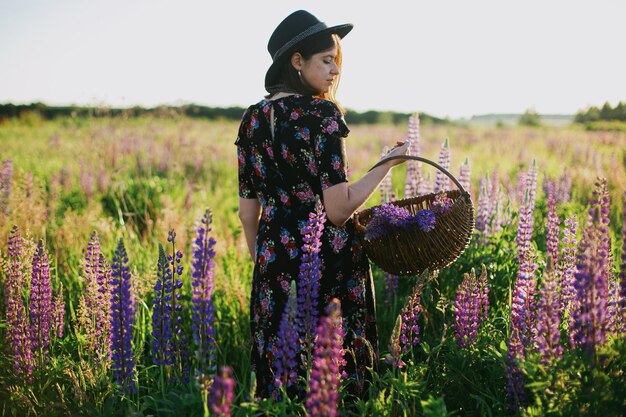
[323,141,409,226]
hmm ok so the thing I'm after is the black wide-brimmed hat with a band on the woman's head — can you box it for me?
[265,10,353,88]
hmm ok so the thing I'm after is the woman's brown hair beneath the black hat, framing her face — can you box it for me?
[266,33,345,113]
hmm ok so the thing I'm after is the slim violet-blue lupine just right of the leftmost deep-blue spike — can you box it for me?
[150,243,172,366]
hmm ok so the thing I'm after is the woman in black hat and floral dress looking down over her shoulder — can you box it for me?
[235,10,409,397]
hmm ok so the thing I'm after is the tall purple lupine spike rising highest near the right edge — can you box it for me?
[572,178,610,354]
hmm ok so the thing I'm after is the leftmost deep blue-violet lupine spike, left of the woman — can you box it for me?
[111,238,137,394]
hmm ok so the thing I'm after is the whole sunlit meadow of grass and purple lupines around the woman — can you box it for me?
[0,114,626,417]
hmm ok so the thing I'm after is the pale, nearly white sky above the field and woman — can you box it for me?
[0,0,626,118]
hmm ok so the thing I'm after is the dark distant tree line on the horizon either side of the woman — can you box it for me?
[0,102,451,125]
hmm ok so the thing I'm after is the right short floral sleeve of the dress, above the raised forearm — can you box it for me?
[315,101,350,190]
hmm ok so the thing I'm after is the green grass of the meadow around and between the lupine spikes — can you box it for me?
[0,115,626,416]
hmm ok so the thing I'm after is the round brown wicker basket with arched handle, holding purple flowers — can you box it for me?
[354,155,474,275]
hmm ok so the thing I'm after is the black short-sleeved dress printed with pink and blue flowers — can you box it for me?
[235,95,378,397]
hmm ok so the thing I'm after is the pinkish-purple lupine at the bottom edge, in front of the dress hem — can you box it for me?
[306,299,345,417]
